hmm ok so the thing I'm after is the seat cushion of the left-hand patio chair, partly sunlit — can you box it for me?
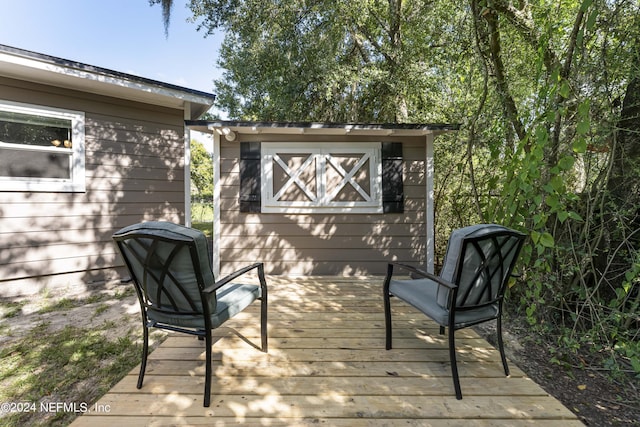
[148,283,262,329]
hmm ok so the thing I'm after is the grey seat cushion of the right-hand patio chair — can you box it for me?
[389,279,498,329]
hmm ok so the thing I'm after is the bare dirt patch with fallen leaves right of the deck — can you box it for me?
[475,320,640,427]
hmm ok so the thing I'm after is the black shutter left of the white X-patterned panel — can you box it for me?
[239,142,261,213]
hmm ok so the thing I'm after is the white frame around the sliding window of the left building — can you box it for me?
[0,100,86,193]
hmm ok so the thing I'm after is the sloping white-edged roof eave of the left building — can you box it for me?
[0,44,215,119]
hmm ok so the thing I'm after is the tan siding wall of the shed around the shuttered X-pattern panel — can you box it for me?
[220,134,426,275]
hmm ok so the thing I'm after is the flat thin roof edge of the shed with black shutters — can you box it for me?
[186,120,460,136]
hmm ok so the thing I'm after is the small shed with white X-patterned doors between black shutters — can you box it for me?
[187,121,458,276]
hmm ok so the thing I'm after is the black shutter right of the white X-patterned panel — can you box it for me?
[382,142,404,213]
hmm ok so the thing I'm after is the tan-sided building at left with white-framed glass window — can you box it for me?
[0,45,215,296]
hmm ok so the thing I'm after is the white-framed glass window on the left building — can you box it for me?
[0,101,85,192]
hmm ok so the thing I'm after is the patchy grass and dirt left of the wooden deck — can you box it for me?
[0,286,156,427]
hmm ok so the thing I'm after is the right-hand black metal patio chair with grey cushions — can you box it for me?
[383,224,525,399]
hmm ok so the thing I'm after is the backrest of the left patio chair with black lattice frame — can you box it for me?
[113,221,216,319]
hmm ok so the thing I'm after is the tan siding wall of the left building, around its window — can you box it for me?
[0,77,185,296]
